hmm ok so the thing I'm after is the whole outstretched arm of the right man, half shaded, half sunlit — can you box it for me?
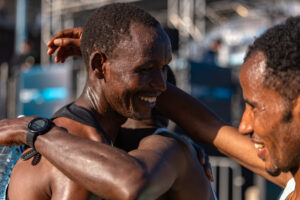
[158,84,291,187]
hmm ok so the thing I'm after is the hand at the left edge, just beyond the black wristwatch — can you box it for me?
[0,117,36,145]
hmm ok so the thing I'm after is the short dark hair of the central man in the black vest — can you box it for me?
[81,3,160,66]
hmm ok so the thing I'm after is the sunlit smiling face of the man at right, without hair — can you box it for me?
[239,52,300,176]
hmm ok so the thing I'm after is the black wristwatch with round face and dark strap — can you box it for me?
[26,117,54,150]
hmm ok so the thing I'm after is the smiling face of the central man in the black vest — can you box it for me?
[101,23,171,119]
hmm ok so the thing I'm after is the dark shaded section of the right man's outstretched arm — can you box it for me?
[158,84,225,144]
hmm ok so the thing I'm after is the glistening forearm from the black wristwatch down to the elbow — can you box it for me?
[35,127,146,199]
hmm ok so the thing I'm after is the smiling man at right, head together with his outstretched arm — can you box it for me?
[159,17,300,199]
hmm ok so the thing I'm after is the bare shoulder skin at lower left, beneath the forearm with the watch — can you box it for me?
[8,147,101,200]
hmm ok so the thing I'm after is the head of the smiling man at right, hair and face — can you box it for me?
[239,17,300,180]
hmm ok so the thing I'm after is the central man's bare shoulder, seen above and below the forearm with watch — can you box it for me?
[8,118,106,200]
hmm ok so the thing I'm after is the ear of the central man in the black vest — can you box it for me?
[89,51,106,78]
